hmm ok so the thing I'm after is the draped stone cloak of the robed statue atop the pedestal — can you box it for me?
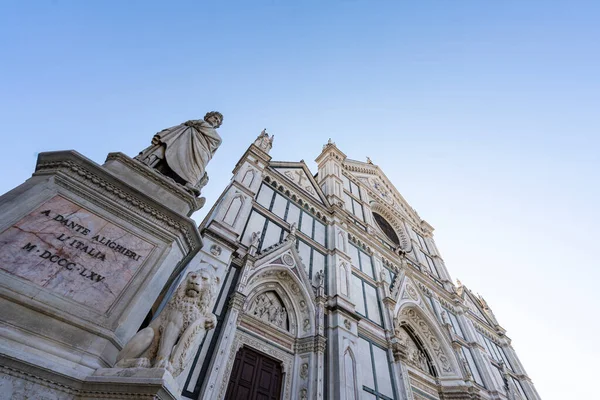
[152,120,222,186]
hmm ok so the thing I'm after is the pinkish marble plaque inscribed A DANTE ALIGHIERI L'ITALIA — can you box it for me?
[0,196,155,313]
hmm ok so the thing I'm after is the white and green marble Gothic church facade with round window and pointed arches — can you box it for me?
[166,131,540,400]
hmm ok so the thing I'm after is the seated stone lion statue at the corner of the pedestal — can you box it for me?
[115,264,219,377]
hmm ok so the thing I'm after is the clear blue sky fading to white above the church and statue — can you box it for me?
[0,0,600,400]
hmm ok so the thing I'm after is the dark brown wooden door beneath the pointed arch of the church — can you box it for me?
[225,347,282,400]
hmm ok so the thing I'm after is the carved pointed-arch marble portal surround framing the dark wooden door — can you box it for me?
[205,244,316,400]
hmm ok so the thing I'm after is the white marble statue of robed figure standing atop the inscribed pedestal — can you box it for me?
[135,111,223,195]
